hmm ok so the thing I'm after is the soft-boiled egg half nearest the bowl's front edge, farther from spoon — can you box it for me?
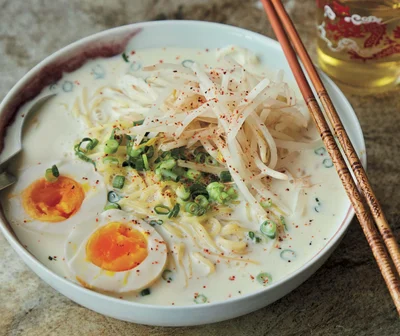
[65,210,168,293]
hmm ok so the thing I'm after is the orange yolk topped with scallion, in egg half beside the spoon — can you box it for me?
[22,176,85,222]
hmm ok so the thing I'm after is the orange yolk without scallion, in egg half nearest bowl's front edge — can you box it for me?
[86,222,148,272]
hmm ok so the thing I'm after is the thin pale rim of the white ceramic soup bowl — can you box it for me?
[0,20,366,311]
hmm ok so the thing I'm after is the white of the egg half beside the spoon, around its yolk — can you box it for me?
[2,160,107,234]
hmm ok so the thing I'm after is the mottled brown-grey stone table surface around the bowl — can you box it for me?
[0,0,400,336]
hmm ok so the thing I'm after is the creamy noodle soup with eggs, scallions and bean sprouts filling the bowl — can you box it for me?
[1,46,348,305]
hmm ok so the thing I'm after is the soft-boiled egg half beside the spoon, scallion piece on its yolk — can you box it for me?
[4,160,107,234]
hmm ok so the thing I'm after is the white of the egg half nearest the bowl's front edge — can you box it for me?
[65,210,168,293]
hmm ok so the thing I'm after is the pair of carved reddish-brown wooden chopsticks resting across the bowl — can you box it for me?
[261,0,400,315]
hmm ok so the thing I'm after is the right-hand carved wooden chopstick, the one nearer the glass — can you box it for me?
[271,0,400,275]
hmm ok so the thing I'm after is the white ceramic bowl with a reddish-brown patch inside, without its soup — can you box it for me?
[0,21,366,326]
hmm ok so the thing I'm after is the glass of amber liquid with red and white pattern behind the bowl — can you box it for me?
[317,0,400,94]
